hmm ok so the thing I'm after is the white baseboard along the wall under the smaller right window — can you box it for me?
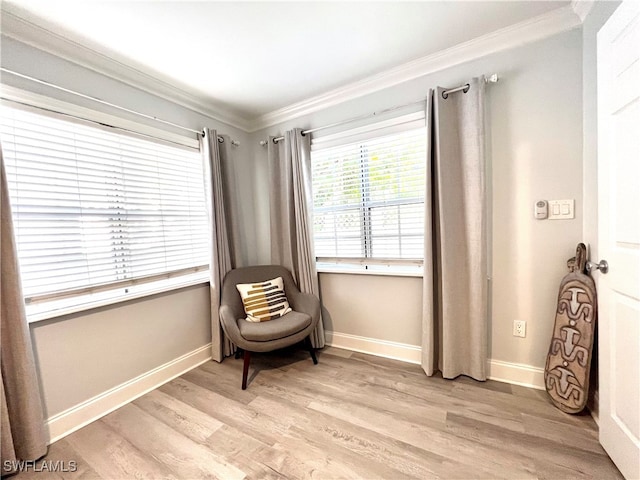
[325,331,544,390]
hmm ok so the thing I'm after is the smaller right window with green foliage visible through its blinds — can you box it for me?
[311,115,426,269]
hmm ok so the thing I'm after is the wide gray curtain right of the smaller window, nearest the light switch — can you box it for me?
[422,78,488,380]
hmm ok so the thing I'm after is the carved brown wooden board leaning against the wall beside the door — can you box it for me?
[544,243,597,413]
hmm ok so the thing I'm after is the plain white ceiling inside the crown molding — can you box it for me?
[2,0,569,127]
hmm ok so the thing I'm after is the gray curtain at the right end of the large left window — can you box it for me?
[200,129,235,362]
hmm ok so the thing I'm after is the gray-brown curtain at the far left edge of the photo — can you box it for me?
[0,147,47,475]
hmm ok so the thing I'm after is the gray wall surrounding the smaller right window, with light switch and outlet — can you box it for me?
[253,29,583,367]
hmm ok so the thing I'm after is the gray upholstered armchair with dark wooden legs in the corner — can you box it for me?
[220,265,320,390]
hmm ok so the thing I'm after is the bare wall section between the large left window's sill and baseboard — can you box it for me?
[31,285,211,418]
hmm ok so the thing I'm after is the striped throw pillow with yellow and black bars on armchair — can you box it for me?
[236,277,291,322]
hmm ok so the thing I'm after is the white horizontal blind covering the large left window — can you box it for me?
[0,106,208,302]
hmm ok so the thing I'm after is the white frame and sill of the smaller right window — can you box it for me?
[311,111,426,277]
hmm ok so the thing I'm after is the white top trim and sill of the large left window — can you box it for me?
[2,89,210,323]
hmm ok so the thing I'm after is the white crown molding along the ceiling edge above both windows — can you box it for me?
[2,0,594,133]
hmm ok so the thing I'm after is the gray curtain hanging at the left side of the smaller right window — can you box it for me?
[268,128,324,348]
